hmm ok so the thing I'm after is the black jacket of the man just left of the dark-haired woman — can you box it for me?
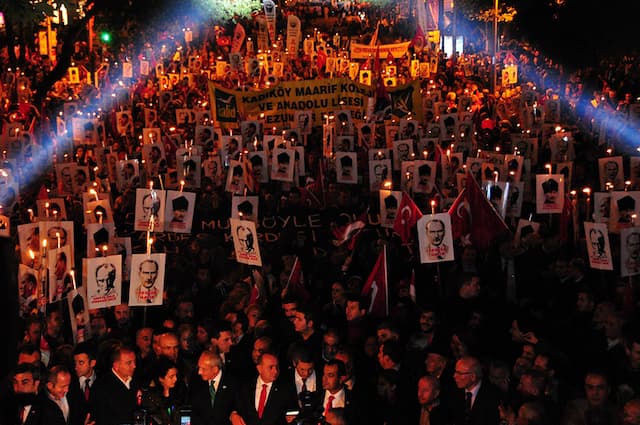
[89,371,142,425]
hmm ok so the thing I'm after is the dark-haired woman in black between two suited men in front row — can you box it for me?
[142,356,184,425]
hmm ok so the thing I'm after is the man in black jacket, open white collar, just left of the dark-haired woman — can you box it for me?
[89,347,142,425]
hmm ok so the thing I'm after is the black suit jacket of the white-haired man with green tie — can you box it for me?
[190,372,239,425]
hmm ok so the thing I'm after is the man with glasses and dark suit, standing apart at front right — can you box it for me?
[448,357,500,425]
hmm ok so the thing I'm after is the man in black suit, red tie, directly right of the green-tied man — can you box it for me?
[229,353,298,425]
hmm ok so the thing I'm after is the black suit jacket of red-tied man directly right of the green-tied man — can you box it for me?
[235,379,299,425]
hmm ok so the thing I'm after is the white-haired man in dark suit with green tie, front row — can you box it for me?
[190,351,238,425]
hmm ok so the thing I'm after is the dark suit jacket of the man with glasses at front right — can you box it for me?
[451,380,500,425]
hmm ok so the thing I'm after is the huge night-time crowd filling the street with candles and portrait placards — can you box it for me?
[0,0,640,425]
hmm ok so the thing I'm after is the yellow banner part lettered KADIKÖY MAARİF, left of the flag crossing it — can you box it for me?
[209,78,373,130]
